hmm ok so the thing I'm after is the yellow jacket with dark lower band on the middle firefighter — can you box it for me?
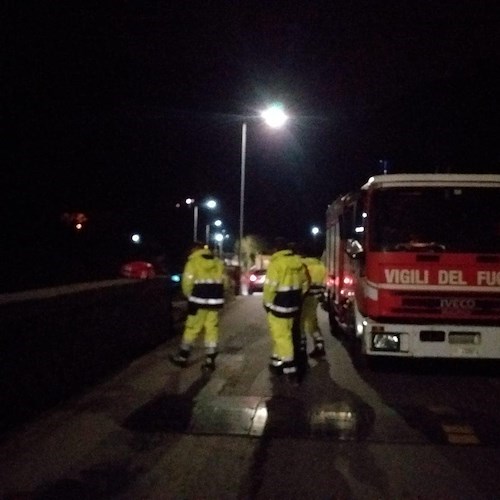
[263,250,309,318]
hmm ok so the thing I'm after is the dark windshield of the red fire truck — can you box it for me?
[367,187,500,253]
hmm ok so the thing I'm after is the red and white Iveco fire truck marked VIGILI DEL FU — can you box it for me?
[324,174,500,364]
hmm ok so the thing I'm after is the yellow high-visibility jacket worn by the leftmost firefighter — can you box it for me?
[182,248,227,309]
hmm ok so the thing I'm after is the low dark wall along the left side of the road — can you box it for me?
[0,277,174,431]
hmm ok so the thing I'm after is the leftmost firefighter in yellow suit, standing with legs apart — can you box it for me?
[169,242,228,371]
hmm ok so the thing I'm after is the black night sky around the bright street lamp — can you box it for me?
[0,0,500,284]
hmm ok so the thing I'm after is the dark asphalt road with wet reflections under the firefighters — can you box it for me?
[0,294,500,499]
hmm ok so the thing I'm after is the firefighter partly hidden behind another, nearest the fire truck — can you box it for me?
[300,244,327,358]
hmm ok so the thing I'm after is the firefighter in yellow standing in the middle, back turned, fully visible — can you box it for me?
[263,238,308,381]
